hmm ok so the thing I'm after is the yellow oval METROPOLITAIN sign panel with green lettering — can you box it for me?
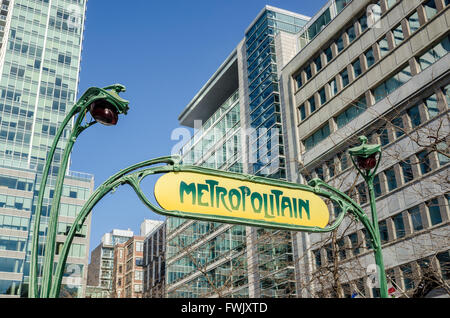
[154,172,330,229]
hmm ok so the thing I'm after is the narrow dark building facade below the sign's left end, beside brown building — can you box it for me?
[143,223,166,298]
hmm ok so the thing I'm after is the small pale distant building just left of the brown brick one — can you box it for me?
[87,229,134,298]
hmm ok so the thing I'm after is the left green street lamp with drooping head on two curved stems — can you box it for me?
[28,84,129,298]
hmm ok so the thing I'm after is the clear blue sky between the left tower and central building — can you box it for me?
[71,0,327,250]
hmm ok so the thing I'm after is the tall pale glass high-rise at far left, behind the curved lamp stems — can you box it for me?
[0,0,94,297]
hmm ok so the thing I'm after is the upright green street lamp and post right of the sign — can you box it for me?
[349,136,388,298]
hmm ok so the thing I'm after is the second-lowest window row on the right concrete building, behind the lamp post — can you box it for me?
[312,195,450,269]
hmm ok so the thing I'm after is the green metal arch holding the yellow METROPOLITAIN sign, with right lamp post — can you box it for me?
[49,137,388,297]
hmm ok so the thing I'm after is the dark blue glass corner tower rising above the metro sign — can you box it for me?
[245,9,308,179]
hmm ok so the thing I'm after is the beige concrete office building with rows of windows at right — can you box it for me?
[280,0,450,297]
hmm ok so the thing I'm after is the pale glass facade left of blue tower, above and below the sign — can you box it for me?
[166,85,248,298]
